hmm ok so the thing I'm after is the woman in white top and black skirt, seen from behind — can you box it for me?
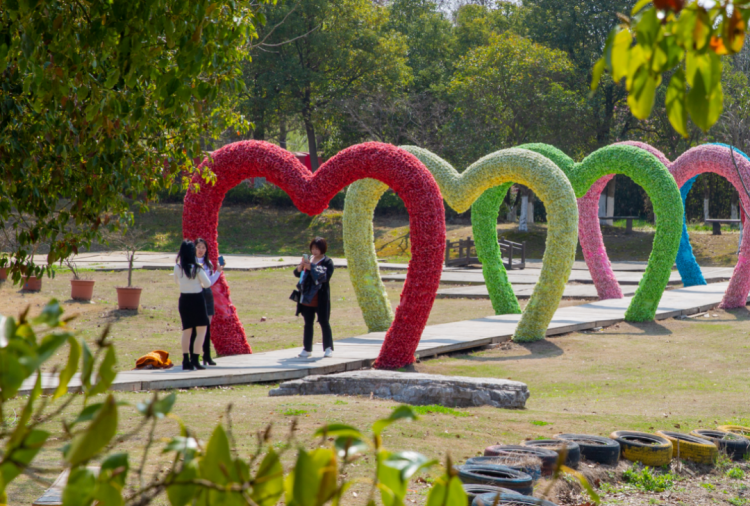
[174,241,211,371]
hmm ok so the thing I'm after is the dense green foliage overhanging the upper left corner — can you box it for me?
[0,0,258,281]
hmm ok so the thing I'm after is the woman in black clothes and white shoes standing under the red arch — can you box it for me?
[294,237,333,358]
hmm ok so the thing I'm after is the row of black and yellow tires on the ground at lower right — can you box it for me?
[457,425,750,506]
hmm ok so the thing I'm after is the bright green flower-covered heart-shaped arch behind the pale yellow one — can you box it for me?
[471,144,684,321]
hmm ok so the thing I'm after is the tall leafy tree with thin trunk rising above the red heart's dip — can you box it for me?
[248,0,409,170]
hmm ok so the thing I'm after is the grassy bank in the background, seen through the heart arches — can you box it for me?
[122,204,739,266]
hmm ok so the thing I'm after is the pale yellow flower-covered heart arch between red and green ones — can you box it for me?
[344,146,578,341]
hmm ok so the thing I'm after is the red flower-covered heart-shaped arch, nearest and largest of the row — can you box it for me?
[183,141,445,368]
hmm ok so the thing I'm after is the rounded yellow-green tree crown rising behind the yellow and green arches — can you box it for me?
[449,32,587,163]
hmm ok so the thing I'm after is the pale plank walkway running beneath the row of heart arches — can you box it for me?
[16,283,728,393]
